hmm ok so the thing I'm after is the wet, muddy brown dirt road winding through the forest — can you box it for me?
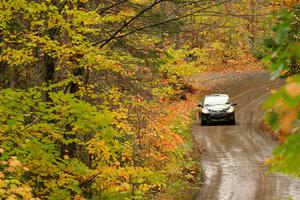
[193,72,300,200]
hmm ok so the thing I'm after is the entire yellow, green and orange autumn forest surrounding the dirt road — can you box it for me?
[0,0,300,199]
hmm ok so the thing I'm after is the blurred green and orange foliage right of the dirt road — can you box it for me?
[264,1,300,176]
